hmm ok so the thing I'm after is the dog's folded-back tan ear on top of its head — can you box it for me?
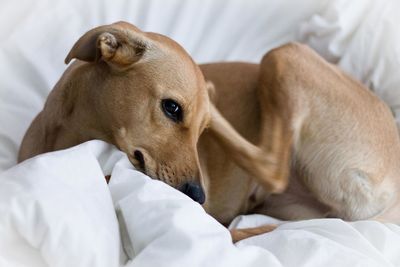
[65,22,149,67]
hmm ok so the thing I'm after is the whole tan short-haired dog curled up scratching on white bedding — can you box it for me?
[19,22,400,241]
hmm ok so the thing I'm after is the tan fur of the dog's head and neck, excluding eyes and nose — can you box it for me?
[19,22,209,187]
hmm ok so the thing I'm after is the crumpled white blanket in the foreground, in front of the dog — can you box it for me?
[0,141,400,267]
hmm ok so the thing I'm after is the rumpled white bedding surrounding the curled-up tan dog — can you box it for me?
[0,0,400,267]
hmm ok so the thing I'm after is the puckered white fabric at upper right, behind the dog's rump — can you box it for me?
[298,0,400,127]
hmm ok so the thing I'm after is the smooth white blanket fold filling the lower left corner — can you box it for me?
[0,142,122,267]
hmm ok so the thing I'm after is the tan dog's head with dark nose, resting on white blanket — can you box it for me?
[65,22,209,203]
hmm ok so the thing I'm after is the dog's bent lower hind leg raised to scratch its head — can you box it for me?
[210,49,293,193]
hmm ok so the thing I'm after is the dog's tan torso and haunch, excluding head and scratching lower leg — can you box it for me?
[199,51,400,222]
